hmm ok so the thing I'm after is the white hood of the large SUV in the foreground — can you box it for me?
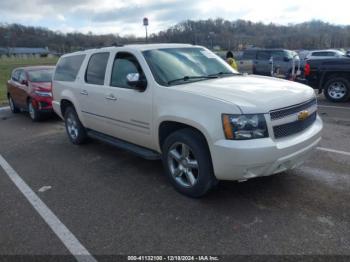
[174,75,315,114]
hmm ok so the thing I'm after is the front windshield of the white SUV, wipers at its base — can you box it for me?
[143,47,238,86]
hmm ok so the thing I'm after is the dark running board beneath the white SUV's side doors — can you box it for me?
[87,130,160,160]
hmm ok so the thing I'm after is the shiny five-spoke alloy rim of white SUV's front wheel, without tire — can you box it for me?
[168,143,199,187]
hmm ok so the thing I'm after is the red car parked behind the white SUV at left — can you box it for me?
[7,66,54,121]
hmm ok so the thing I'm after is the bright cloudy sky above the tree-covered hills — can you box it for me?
[0,0,350,36]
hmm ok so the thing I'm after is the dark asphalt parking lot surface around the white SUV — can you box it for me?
[0,96,350,260]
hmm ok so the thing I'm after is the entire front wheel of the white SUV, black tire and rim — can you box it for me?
[162,128,217,198]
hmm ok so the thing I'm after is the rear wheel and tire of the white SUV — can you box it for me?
[64,106,87,145]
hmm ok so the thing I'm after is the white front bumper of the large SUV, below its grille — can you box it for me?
[210,116,323,181]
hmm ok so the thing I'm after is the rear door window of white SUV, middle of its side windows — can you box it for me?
[85,53,109,85]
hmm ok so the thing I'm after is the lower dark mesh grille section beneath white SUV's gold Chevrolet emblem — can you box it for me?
[273,112,317,138]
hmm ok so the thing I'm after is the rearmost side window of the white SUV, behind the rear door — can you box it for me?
[54,55,85,82]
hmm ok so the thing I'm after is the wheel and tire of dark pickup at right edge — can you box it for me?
[323,77,350,102]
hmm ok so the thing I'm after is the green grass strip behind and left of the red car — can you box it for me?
[0,57,58,105]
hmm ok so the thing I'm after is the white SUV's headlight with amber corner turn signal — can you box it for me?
[222,114,268,140]
